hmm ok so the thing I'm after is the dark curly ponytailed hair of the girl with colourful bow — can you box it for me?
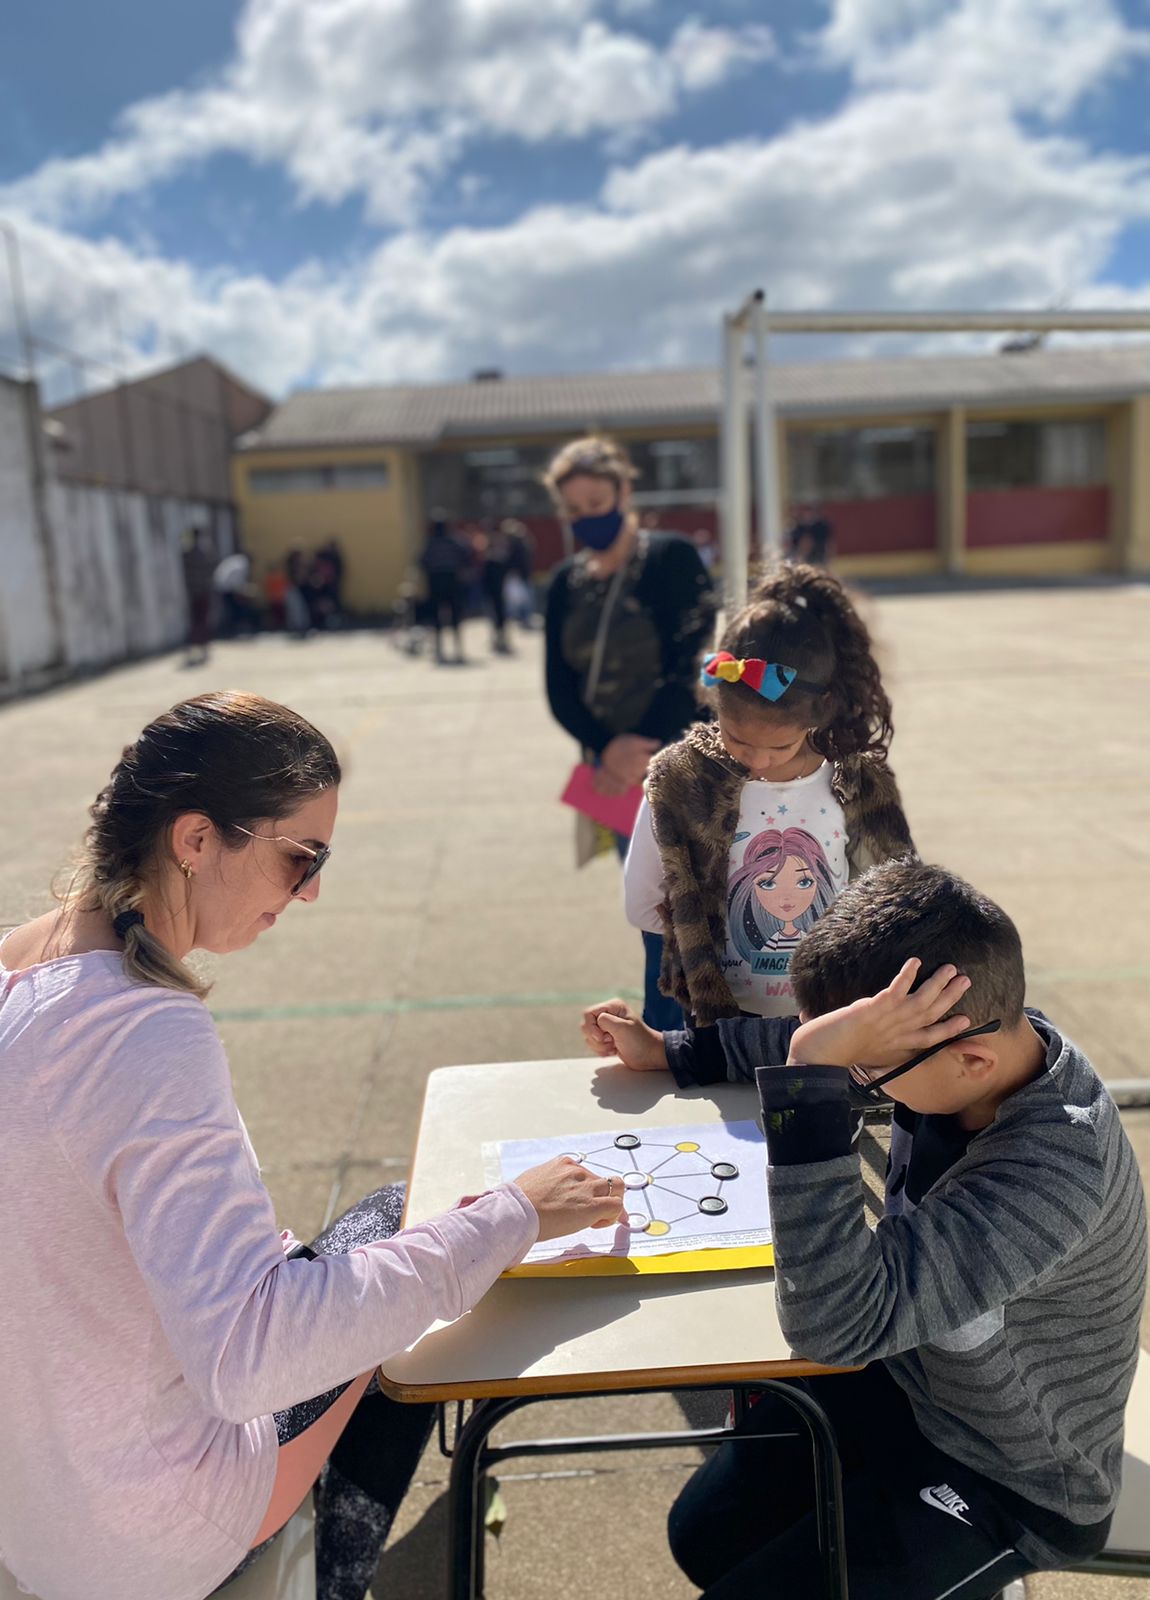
[718,563,894,762]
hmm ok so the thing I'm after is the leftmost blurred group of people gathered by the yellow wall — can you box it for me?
[184,528,345,666]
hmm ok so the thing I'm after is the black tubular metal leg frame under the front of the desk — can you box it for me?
[448,1378,848,1600]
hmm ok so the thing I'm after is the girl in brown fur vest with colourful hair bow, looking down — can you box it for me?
[584,565,913,1085]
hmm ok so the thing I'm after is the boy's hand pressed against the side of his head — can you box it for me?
[787,957,971,1067]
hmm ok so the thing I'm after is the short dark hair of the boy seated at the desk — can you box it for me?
[790,858,1027,1027]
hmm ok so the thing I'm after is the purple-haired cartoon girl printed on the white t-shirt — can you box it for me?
[726,827,838,963]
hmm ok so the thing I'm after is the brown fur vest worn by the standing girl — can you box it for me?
[646,723,915,1027]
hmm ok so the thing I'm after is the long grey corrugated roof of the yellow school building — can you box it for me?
[242,344,1150,450]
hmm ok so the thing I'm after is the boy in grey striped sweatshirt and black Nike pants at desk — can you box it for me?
[670,861,1145,1600]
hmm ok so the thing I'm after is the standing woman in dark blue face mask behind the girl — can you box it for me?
[544,437,715,1030]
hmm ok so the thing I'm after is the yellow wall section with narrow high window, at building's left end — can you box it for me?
[232,448,419,613]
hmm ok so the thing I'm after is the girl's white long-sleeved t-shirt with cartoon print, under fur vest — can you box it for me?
[624,762,849,1016]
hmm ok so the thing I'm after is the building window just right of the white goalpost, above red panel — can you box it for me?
[787,427,934,501]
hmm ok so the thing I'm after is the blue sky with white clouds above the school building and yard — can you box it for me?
[0,0,1150,394]
